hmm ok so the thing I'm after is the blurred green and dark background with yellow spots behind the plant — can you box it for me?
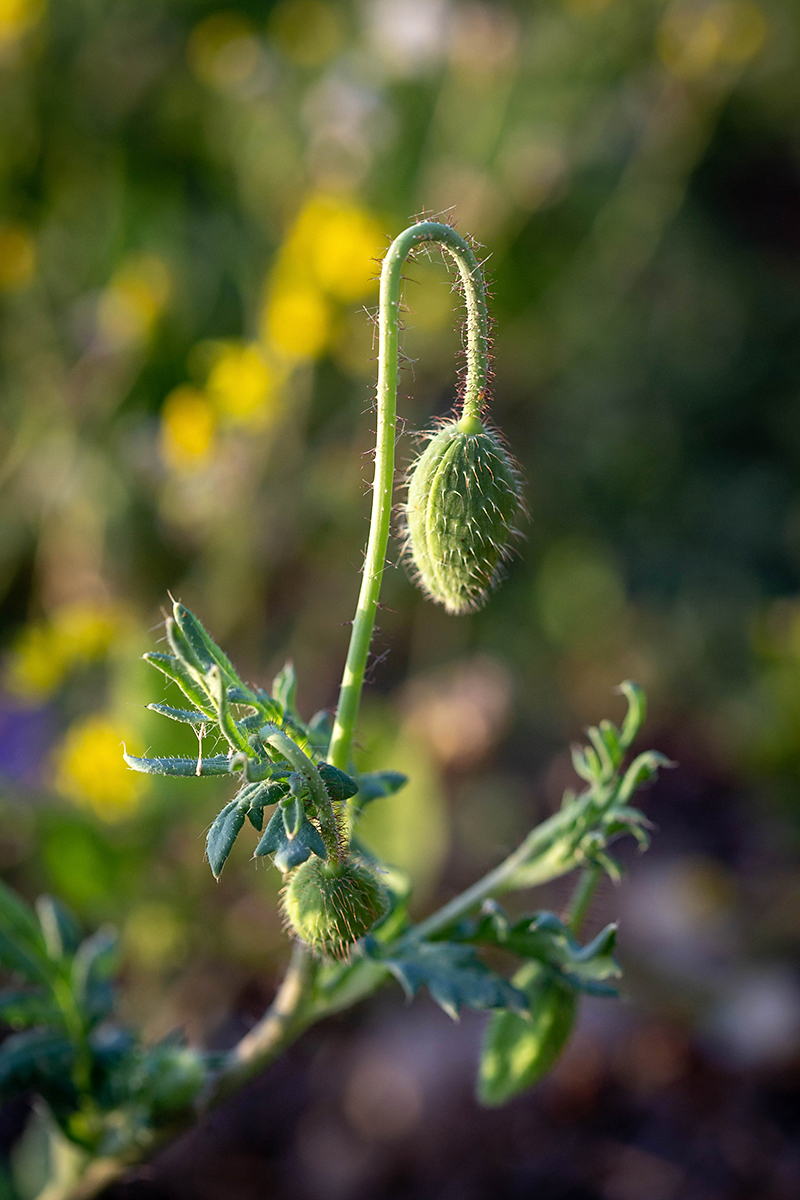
[0,0,800,1200]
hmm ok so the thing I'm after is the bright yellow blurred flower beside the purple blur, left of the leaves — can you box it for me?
[55,716,145,821]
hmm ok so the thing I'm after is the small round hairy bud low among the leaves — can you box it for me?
[283,856,389,959]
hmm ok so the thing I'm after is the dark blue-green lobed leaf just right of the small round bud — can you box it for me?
[381,942,525,1020]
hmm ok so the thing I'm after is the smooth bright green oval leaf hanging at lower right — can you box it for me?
[477,962,577,1106]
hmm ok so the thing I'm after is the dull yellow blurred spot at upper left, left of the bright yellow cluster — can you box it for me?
[97,254,172,348]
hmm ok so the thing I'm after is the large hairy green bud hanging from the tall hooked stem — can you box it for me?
[405,416,522,613]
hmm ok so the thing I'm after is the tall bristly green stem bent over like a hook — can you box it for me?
[329,221,489,770]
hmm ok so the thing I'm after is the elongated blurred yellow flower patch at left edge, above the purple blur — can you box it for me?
[5,604,125,701]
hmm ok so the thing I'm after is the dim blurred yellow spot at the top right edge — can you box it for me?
[656,0,769,79]
